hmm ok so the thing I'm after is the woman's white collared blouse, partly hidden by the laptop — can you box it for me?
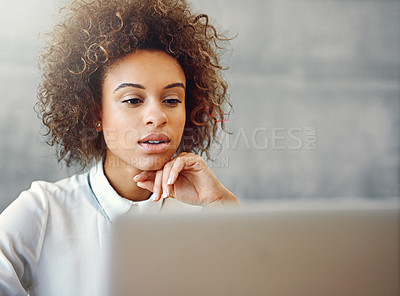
[0,162,199,296]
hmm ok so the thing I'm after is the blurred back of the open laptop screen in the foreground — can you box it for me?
[108,202,400,296]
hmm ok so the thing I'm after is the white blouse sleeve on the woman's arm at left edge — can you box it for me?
[0,182,49,296]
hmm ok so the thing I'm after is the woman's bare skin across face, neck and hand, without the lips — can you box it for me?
[101,50,237,206]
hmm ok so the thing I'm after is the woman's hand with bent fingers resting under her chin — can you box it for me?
[133,152,238,207]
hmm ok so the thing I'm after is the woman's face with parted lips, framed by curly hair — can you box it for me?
[101,50,186,171]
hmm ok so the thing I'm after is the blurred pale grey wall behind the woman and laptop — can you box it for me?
[0,0,400,212]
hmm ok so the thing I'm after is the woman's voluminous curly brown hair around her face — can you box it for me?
[37,0,231,168]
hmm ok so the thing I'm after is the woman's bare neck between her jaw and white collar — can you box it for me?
[104,154,152,201]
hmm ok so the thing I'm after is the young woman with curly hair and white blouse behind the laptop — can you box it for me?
[0,0,237,296]
